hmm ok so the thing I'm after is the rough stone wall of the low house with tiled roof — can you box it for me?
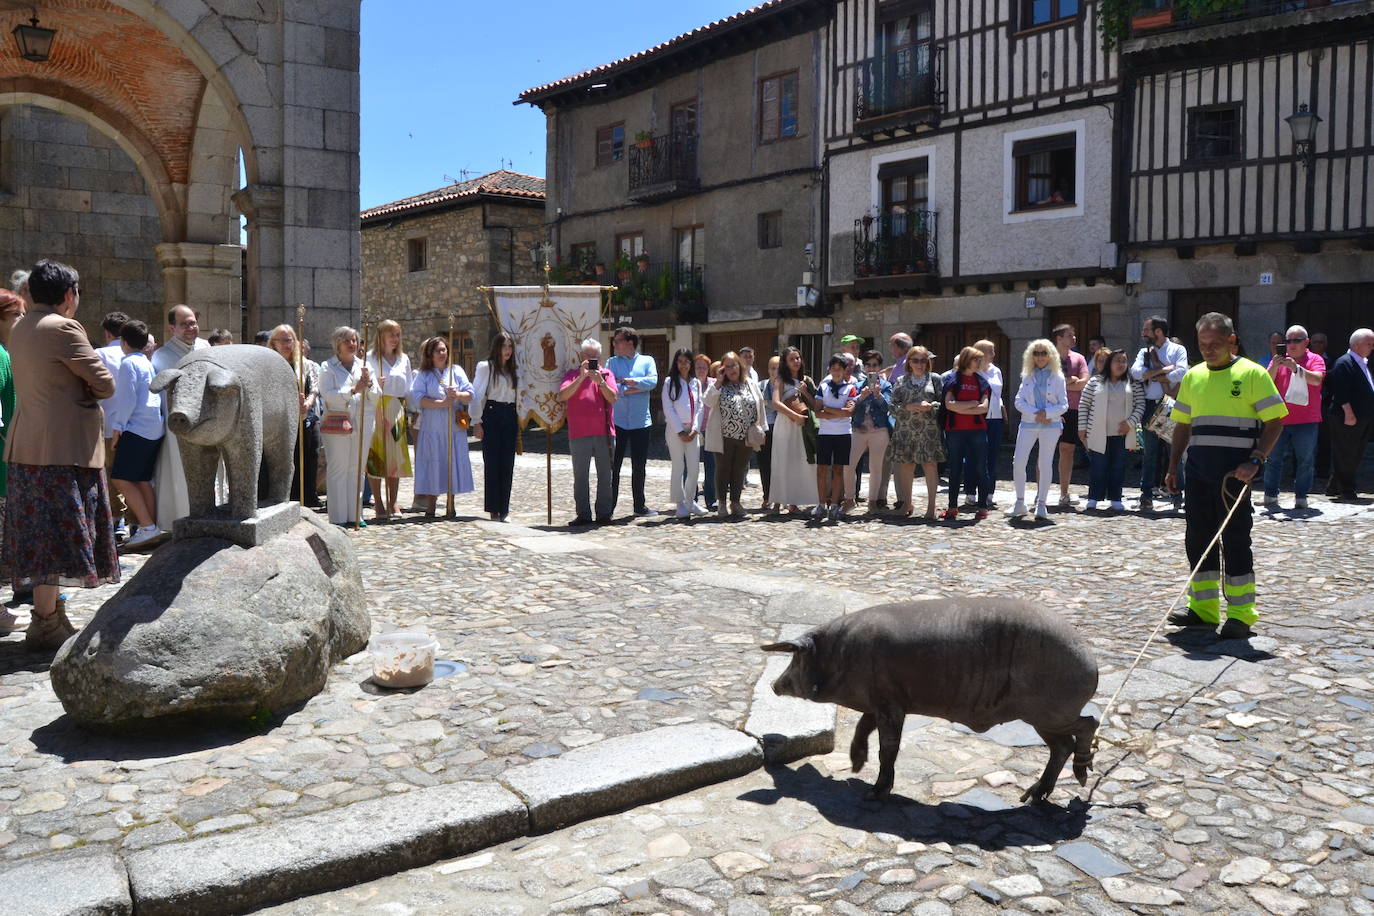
[362,201,544,371]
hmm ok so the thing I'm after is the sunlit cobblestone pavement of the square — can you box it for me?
[0,444,1374,915]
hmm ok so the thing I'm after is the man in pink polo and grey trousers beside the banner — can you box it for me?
[558,338,617,526]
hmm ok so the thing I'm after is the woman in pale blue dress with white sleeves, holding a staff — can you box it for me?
[411,336,474,518]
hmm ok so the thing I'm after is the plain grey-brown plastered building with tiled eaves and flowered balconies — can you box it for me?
[518,0,830,365]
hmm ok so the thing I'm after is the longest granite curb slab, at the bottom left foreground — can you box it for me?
[122,783,529,916]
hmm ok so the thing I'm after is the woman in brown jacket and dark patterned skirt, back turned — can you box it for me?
[0,261,120,650]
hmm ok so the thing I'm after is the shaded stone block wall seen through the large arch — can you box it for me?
[0,106,165,345]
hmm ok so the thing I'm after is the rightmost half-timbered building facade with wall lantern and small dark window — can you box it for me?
[1117,0,1374,358]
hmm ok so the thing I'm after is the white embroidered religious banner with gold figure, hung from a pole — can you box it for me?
[492,286,602,433]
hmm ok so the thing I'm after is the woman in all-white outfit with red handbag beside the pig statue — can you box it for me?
[320,327,381,525]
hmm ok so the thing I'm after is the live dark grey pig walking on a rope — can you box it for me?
[763,597,1098,802]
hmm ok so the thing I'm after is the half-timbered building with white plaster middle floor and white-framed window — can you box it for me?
[823,0,1138,368]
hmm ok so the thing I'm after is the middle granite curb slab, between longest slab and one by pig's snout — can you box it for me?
[502,722,763,831]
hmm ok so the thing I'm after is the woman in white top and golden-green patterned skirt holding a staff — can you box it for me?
[367,319,412,520]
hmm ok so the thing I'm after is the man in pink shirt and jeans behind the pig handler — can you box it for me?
[1264,324,1326,509]
